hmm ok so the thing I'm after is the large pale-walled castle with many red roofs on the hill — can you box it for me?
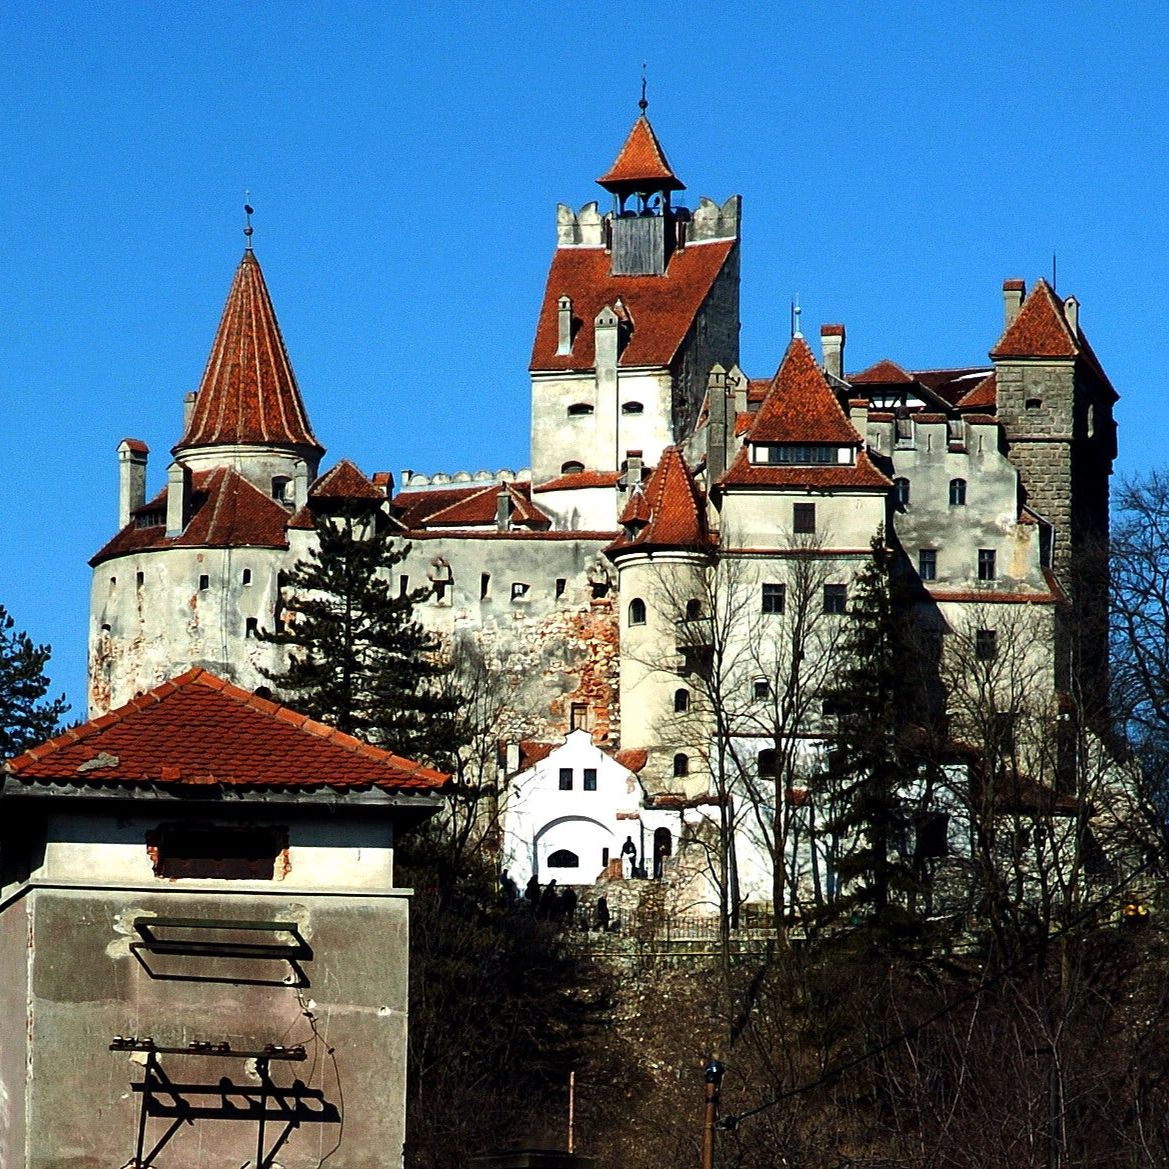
[89,108,1116,899]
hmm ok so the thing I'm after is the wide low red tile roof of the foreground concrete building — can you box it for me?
[6,670,449,791]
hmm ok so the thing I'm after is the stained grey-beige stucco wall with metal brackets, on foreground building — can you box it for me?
[10,886,407,1169]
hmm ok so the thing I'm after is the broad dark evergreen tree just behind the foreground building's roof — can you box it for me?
[260,509,461,767]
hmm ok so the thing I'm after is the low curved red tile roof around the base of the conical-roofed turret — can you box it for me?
[90,466,289,566]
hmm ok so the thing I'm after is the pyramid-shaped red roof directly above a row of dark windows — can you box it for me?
[747,337,862,447]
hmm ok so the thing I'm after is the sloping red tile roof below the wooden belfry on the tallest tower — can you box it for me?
[532,240,735,369]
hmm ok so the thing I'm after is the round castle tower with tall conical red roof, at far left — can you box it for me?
[89,247,329,715]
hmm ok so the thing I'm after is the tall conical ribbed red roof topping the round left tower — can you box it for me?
[174,249,324,455]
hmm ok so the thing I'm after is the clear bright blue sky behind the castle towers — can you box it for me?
[0,0,1169,714]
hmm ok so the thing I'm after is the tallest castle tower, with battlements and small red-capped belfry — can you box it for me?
[531,108,740,493]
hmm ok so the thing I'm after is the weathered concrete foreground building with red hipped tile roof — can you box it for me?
[0,670,447,1169]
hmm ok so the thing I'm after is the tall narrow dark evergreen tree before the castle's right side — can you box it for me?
[825,532,916,928]
